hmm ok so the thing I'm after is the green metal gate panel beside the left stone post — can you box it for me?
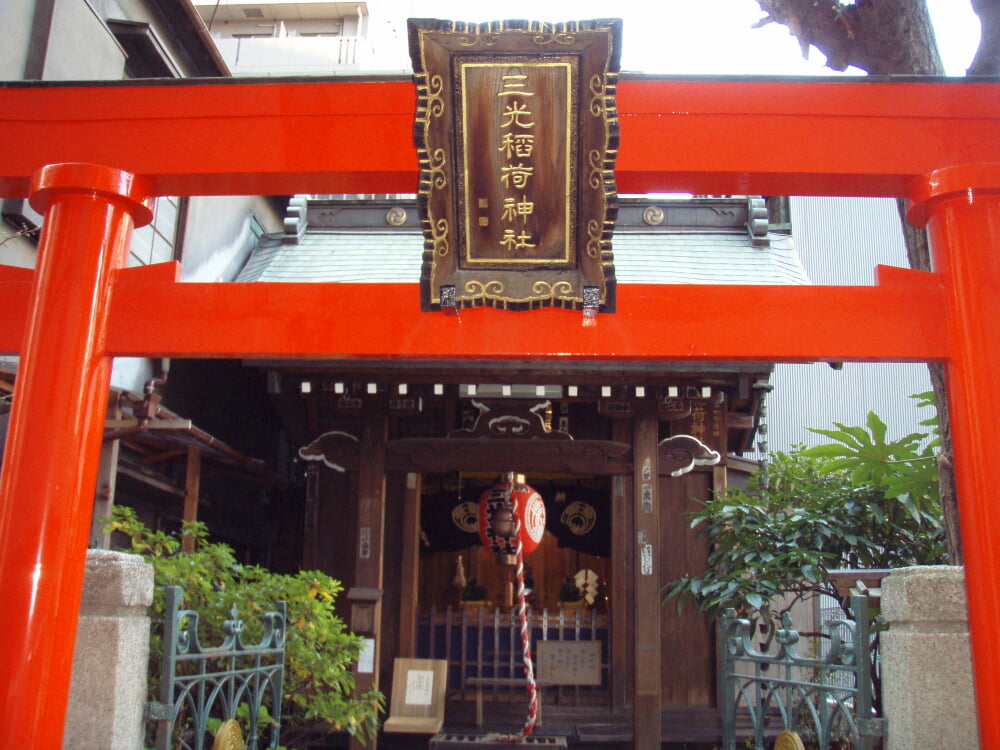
[146,586,287,750]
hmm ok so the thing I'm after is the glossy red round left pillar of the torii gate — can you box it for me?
[0,164,153,749]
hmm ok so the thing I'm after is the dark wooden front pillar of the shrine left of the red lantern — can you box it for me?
[350,403,389,750]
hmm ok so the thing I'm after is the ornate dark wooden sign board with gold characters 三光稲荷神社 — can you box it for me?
[409,19,621,312]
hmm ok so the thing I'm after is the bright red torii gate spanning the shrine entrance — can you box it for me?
[0,79,1000,750]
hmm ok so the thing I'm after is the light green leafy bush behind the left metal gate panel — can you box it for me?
[106,506,384,746]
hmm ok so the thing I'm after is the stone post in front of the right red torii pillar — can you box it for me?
[882,565,979,750]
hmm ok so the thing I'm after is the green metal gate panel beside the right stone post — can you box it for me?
[721,596,885,750]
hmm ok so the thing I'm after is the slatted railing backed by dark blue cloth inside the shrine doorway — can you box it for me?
[417,607,610,707]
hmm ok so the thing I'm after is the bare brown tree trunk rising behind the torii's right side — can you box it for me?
[758,0,968,565]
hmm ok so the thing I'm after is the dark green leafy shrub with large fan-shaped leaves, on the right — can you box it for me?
[664,402,947,618]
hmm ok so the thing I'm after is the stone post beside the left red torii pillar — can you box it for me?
[63,550,153,750]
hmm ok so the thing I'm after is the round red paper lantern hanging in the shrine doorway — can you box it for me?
[479,474,545,556]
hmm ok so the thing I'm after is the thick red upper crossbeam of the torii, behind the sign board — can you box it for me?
[0,76,1000,196]
